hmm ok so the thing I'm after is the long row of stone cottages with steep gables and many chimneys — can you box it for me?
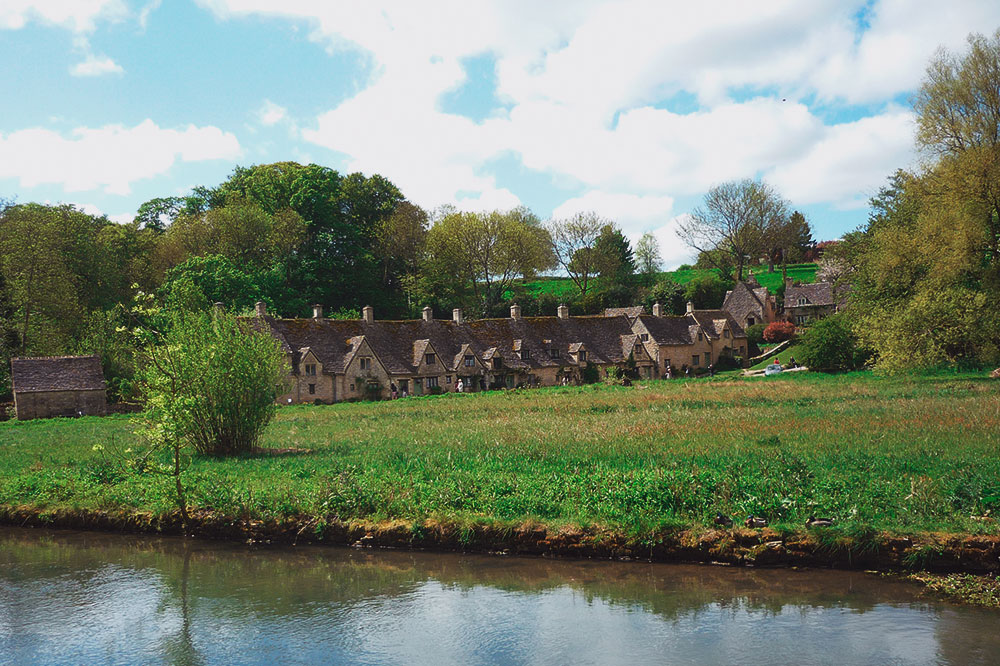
[254,303,747,403]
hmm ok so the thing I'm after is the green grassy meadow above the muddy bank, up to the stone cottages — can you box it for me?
[0,373,1000,537]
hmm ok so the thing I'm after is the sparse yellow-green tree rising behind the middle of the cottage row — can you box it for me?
[422,208,553,315]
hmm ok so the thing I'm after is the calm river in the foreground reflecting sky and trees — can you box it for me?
[0,528,1000,665]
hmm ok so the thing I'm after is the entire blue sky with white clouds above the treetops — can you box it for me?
[0,0,1000,268]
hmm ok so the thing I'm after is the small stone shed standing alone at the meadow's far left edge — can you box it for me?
[10,355,108,420]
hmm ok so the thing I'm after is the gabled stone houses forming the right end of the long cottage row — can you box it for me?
[633,303,748,377]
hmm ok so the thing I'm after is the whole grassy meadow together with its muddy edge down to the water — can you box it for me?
[0,373,1000,588]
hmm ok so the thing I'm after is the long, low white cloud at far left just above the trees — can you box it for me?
[0,119,240,194]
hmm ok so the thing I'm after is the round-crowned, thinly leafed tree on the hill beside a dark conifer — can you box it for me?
[677,179,788,281]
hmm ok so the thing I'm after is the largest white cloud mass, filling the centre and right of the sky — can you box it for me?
[200,0,1000,218]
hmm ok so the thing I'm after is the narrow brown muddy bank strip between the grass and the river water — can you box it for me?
[0,507,1000,574]
